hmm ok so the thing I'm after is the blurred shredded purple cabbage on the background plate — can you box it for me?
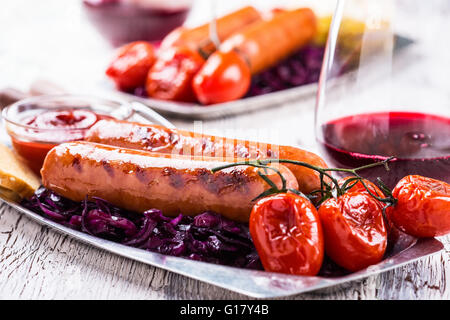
[129,46,325,98]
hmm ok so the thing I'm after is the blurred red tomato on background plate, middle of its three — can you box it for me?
[146,47,205,102]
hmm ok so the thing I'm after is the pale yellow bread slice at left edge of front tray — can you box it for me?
[0,143,41,198]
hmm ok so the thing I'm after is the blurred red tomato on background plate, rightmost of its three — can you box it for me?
[192,51,251,104]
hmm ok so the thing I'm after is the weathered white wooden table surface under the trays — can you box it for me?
[0,0,450,300]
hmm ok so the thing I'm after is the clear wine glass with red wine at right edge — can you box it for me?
[315,0,450,188]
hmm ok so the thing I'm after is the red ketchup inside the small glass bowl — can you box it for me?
[11,109,113,175]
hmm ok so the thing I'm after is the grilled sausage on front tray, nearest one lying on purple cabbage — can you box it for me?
[41,142,297,221]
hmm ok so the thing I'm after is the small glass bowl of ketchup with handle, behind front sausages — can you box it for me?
[2,95,133,174]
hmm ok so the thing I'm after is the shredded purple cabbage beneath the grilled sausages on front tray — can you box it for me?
[22,187,262,270]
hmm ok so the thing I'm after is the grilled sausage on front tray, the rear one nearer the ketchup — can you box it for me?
[86,120,327,193]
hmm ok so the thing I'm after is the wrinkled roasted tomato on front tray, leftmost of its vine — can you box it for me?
[249,193,324,276]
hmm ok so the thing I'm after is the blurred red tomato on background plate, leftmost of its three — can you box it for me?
[106,41,155,90]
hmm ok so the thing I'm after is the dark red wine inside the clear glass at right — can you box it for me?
[320,112,450,188]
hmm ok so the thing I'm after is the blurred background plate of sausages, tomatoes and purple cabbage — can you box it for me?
[103,7,413,119]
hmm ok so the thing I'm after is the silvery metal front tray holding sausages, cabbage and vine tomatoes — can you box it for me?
[0,199,444,298]
